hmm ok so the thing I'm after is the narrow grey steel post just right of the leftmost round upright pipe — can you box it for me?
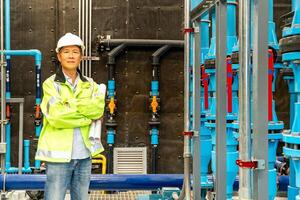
[193,22,201,199]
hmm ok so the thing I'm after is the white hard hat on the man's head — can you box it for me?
[55,33,85,53]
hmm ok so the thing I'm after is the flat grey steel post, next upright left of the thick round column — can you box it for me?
[215,0,227,200]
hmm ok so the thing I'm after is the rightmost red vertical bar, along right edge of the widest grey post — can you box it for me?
[268,49,274,121]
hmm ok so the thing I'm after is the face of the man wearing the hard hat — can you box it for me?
[57,45,82,71]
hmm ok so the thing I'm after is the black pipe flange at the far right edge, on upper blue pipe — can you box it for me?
[279,35,300,54]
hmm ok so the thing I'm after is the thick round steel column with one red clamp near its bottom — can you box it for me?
[239,0,252,199]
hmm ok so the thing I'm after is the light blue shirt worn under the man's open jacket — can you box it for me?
[64,73,91,159]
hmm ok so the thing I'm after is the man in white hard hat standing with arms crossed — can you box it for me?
[36,33,105,200]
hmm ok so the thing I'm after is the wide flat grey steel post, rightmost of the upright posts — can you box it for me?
[252,0,268,199]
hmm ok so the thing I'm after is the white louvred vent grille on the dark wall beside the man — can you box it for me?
[114,147,147,174]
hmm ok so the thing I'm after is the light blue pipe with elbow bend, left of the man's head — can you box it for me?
[0,49,42,66]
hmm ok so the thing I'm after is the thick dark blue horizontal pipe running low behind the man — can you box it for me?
[0,174,289,191]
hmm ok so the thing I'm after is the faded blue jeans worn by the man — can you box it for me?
[45,158,92,200]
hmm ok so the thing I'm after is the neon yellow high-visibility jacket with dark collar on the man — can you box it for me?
[35,69,105,162]
